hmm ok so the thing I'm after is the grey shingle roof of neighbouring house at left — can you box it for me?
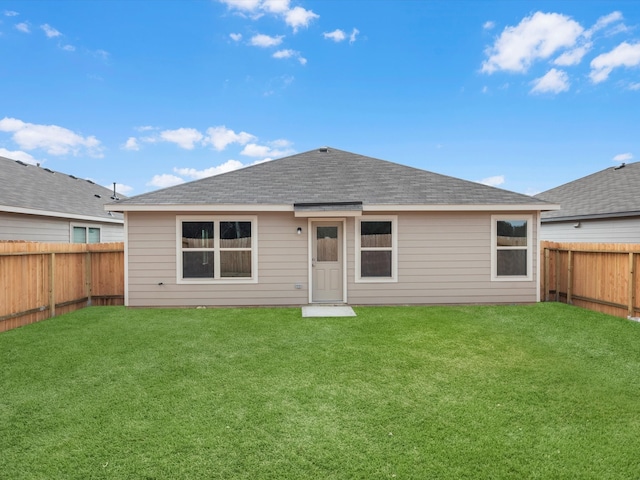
[0,157,124,223]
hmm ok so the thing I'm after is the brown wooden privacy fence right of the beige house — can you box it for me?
[540,242,640,317]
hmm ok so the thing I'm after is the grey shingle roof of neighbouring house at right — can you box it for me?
[536,162,640,222]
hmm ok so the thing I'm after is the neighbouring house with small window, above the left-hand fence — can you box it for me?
[0,157,124,243]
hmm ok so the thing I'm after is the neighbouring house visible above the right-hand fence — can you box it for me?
[536,162,640,243]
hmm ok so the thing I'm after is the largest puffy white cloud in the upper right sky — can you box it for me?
[482,12,584,74]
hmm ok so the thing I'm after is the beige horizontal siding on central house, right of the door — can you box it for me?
[347,212,537,305]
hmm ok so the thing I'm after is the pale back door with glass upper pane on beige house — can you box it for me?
[311,222,344,303]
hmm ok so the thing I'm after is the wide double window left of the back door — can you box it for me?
[177,217,257,283]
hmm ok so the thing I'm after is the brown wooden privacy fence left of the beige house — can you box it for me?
[0,242,124,332]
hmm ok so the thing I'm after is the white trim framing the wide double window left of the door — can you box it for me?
[176,215,258,285]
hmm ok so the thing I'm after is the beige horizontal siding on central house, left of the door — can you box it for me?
[127,212,309,307]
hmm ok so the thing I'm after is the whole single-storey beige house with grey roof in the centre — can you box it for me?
[106,147,557,307]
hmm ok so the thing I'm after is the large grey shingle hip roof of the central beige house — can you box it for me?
[107,147,557,211]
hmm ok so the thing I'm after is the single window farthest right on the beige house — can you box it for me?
[491,215,533,280]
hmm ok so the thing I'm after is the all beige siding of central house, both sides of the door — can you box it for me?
[128,212,538,307]
